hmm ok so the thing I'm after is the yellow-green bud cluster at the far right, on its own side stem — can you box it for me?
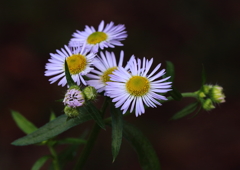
[197,85,225,111]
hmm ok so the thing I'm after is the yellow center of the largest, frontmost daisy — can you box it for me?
[126,76,150,96]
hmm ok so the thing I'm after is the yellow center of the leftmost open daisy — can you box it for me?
[67,54,87,74]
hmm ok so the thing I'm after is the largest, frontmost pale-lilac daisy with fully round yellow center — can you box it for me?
[106,58,171,117]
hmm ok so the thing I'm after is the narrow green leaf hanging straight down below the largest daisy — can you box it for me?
[110,104,123,162]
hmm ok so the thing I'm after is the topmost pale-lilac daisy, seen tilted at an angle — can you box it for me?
[69,21,127,52]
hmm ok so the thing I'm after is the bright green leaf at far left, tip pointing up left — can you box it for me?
[11,111,38,134]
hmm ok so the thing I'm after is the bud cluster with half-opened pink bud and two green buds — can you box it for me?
[63,85,97,118]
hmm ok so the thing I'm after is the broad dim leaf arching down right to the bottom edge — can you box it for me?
[123,122,160,170]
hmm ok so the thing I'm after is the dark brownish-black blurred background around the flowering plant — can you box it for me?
[0,0,240,170]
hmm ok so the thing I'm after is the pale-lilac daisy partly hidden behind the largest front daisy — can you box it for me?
[87,51,131,93]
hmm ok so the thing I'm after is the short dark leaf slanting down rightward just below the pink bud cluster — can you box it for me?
[85,102,106,130]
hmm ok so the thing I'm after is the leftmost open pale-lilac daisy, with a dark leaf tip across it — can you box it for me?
[45,45,95,86]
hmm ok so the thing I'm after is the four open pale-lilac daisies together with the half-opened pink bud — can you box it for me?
[45,21,171,116]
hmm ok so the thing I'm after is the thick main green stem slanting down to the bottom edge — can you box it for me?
[74,98,108,170]
